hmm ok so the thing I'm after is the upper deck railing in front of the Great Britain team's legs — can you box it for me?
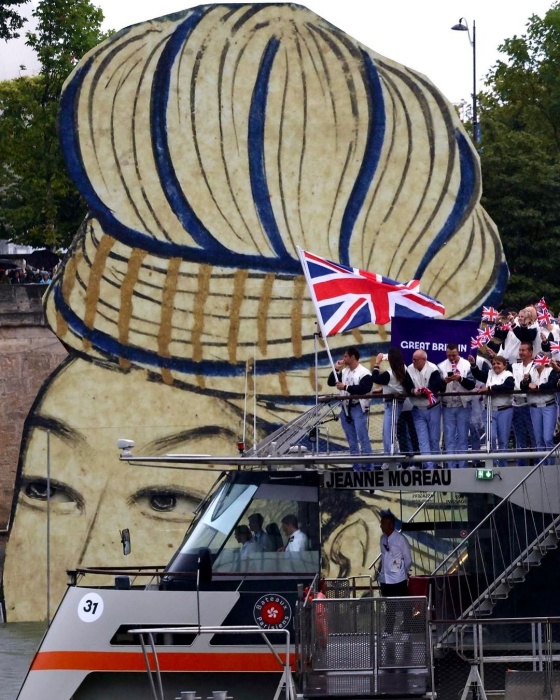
[247,391,556,468]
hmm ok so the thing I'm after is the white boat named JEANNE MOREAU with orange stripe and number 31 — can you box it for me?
[14,402,560,700]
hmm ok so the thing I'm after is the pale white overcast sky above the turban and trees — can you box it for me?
[0,0,553,103]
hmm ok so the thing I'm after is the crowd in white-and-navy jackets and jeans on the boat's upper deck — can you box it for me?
[328,299,560,470]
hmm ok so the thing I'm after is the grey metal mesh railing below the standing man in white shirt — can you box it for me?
[295,580,433,698]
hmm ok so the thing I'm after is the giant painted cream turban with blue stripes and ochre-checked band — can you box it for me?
[47,4,507,395]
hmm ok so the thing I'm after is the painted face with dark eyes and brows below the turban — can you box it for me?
[4,360,240,621]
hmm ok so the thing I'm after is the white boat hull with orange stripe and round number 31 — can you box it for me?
[18,587,285,700]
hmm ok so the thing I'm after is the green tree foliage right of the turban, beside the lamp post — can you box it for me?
[480,3,560,310]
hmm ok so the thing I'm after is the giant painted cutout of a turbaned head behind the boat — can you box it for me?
[4,4,507,620]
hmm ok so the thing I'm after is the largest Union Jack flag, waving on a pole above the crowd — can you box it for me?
[298,248,445,337]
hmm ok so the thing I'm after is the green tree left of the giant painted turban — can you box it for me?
[0,0,103,247]
